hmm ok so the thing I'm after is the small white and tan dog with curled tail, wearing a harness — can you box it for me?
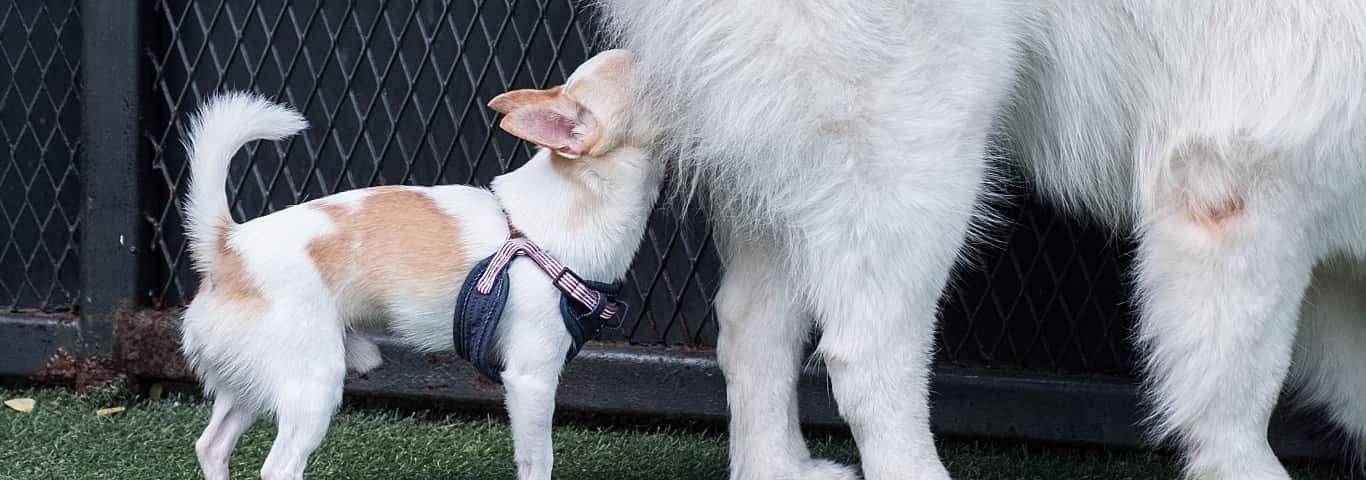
[182,51,661,480]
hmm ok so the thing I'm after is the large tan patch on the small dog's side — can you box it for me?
[309,187,471,310]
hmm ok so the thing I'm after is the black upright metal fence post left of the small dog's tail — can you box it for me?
[79,0,149,356]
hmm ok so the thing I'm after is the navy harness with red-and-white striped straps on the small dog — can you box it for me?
[455,224,627,384]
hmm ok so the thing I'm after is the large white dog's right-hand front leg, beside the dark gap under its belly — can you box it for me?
[802,157,981,480]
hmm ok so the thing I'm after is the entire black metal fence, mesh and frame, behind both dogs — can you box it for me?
[0,0,1327,459]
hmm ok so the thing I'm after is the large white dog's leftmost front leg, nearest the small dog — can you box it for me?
[716,242,855,480]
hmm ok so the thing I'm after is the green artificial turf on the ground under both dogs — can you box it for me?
[0,388,1346,480]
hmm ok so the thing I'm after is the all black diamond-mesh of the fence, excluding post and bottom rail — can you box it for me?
[0,0,1134,375]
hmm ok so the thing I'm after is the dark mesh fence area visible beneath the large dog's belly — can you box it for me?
[937,180,1137,376]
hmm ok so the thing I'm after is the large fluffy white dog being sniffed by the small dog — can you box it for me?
[601,0,1366,480]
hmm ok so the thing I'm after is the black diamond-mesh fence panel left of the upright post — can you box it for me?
[0,0,81,312]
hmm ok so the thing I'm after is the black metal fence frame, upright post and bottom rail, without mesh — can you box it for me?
[0,0,1336,458]
